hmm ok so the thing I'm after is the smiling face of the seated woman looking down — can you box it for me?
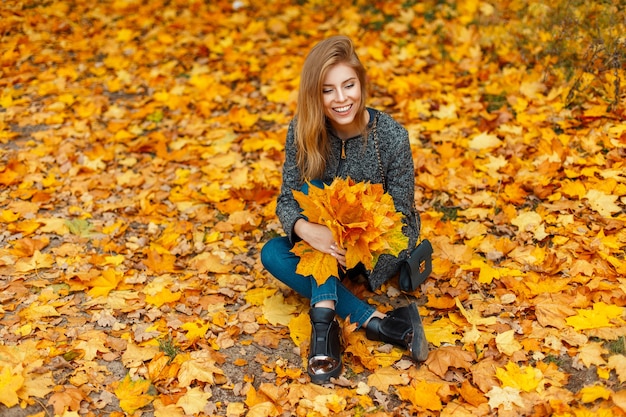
[322,63,361,139]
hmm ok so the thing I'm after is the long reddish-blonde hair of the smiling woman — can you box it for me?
[296,35,367,180]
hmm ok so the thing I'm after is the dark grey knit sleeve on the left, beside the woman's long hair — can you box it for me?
[276,121,304,243]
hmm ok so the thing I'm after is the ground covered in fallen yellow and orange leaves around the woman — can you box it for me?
[0,0,626,417]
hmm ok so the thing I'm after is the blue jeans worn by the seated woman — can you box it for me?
[261,180,375,327]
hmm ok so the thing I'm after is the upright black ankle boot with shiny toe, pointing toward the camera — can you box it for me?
[307,307,342,384]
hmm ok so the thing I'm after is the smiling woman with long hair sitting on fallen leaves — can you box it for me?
[261,36,428,383]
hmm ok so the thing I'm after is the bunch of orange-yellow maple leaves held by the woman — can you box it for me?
[291,177,409,285]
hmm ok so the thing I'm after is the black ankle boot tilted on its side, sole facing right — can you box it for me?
[365,304,428,361]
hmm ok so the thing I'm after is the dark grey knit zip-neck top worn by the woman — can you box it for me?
[276,109,419,289]
